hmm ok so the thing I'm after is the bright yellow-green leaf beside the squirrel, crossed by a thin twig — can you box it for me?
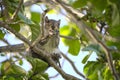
[60,25,80,56]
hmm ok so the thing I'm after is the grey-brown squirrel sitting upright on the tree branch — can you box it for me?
[32,16,61,67]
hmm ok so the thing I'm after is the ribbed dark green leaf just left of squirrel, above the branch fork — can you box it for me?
[30,23,41,41]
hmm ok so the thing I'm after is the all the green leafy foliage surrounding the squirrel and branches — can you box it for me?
[0,0,120,80]
